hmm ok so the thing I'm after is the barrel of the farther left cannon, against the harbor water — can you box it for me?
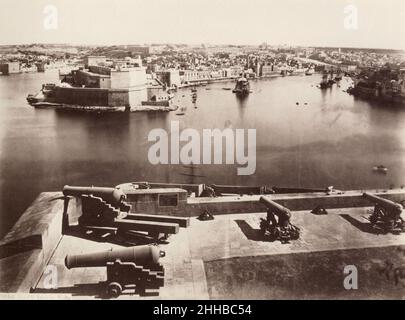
[63,186,126,205]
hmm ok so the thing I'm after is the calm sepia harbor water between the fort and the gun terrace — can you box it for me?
[0,70,405,237]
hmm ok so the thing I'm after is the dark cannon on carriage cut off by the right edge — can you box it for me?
[363,192,405,233]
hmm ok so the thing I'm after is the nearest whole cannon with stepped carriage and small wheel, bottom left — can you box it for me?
[65,246,165,297]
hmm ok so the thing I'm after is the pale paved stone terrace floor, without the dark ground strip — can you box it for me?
[30,208,405,299]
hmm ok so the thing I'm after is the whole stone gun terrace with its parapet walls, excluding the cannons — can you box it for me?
[0,184,405,299]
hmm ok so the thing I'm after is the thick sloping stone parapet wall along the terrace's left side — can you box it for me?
[0,192,76,293]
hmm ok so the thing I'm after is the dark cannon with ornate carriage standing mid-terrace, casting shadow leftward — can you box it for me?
[259,196,300,243]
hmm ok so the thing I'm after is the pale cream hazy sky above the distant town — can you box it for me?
[0,0,405,49]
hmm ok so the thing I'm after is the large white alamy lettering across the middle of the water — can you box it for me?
[148,121,256,175]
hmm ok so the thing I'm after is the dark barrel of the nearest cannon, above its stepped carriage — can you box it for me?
[65,246,165,269]
